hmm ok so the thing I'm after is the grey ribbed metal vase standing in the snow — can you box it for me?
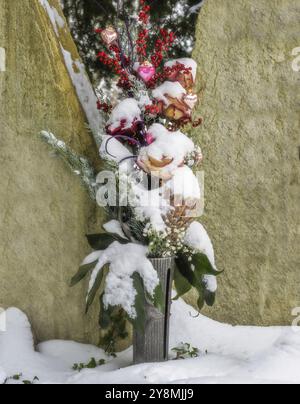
[133,258,175,365]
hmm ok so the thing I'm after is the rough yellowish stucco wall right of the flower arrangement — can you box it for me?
[194,0,300,325]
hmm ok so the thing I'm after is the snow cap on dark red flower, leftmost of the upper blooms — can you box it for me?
[107,98,141,133]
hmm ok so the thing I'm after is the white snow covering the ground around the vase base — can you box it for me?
[0,300,300,384]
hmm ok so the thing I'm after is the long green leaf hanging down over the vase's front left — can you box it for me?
[129,272,146,333]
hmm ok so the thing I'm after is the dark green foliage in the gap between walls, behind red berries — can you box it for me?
[61,0,200,84]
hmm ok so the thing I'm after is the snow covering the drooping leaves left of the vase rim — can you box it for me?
[82,242,159,319]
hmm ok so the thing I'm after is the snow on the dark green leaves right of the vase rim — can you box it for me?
[185,222,218,293]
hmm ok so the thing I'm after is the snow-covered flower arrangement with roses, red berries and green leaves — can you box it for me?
[43,0,220,352]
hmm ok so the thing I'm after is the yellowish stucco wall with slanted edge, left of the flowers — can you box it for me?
[0,0,102,343]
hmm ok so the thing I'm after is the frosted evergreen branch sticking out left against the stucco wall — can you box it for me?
[40,131,96,201]
